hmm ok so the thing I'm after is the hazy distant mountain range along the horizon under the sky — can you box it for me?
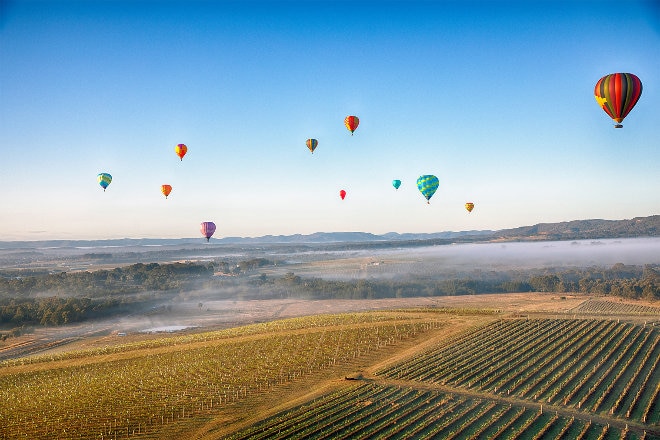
[0,215,660,249]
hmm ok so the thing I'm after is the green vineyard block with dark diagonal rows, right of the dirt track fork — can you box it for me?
[378,319,660,424]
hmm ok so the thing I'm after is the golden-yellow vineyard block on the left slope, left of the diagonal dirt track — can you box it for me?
[0,321,433,439]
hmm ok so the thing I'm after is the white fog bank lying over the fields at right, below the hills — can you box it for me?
[286,237,660,279]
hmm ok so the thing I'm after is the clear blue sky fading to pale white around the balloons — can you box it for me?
[0,0,660,240]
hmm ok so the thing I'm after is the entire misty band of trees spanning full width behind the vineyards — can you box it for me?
[0,258,660,337]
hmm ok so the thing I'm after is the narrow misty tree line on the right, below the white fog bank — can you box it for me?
[252,263,660,300]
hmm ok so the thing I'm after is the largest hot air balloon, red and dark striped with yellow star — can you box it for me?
[594,73,642,128]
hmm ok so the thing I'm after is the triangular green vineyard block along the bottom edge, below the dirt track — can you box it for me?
[228,383,655,440]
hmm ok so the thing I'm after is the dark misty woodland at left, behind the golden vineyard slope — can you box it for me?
[0,259,268,339]
